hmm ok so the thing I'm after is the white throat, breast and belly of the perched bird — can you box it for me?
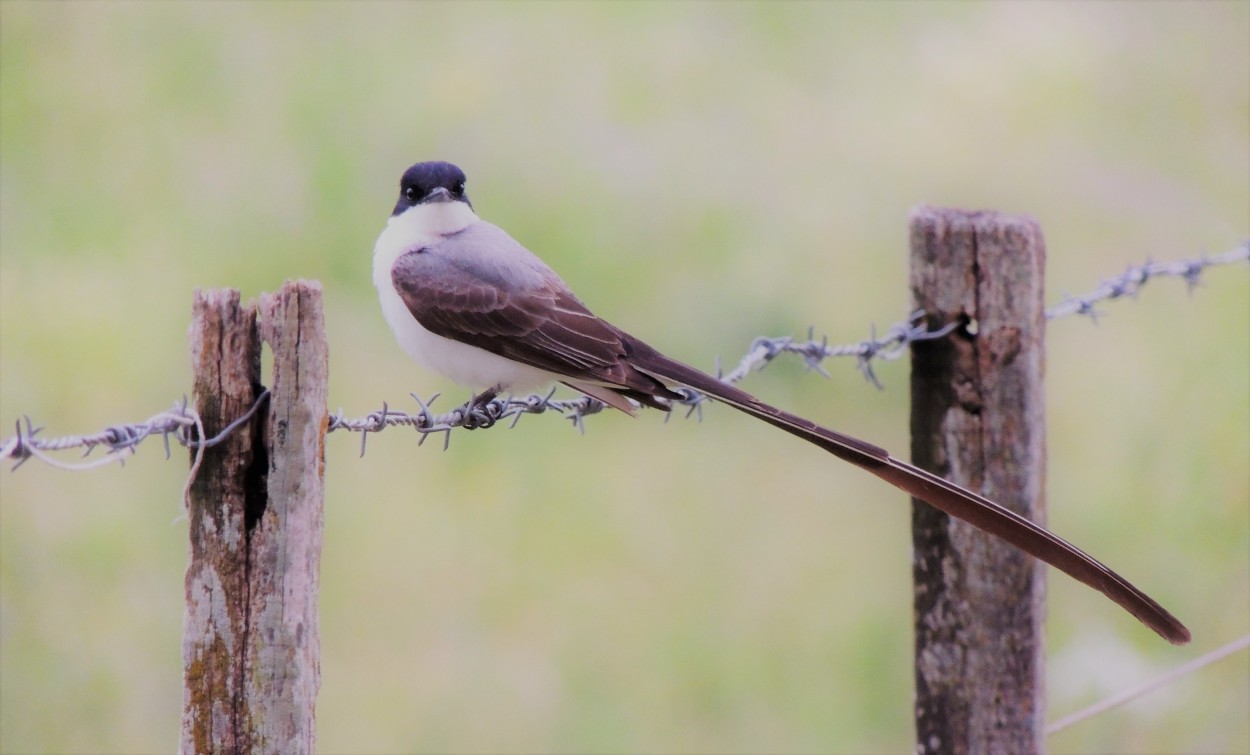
[374,203,558,393]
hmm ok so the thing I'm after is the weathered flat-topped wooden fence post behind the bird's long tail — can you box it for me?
[910,206,1046,753]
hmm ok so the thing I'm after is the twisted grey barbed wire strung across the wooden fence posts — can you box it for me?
[0,241,1250,470]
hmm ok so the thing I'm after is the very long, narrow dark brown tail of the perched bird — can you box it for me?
[630,344,1190,645]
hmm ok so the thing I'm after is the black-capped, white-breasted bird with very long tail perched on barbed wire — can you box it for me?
[373,161,1190,645]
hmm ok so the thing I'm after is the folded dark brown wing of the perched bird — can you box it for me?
[391,250,676,405]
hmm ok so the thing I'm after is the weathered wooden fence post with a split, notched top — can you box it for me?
[180,281,329,754]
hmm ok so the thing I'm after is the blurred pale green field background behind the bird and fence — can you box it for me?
[0,1,1250,753]
